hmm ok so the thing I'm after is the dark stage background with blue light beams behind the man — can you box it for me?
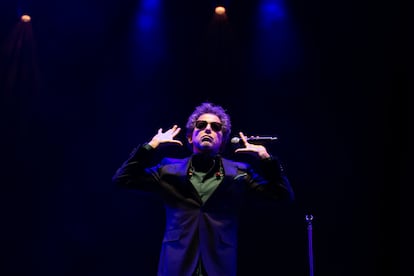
[0,0,409,276]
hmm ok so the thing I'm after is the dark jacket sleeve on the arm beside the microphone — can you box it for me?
[249,157,294,201]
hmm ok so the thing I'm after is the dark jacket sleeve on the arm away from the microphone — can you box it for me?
[112,144,162,191]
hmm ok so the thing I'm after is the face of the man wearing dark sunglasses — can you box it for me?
[188,113,223,154]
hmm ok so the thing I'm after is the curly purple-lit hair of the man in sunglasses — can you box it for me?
[186,102,231,150]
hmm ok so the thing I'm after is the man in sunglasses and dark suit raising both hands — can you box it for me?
[113,103,293,276]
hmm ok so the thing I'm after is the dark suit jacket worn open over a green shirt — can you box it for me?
[113,146,293,276]
